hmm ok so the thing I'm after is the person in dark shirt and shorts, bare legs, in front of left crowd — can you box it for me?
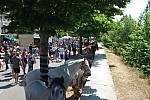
[12,52,22,84]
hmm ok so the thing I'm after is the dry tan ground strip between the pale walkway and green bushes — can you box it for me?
[104,47,150,100]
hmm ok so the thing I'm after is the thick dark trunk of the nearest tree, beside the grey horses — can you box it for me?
[40,31,48,86]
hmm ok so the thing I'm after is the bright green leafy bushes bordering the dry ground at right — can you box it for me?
[102,2,150,76]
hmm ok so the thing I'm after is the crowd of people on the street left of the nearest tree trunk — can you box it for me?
[0,41,38,84]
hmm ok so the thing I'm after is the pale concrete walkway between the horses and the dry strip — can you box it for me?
[80,43,117,100]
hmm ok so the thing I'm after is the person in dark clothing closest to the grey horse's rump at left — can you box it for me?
[27,50,36,72]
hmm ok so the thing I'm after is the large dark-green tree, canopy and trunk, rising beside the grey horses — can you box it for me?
[0,0,130,84]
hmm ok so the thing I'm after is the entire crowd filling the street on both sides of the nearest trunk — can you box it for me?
[0,39,97,84]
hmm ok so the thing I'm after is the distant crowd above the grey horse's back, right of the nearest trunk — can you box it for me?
[48,40,79,62]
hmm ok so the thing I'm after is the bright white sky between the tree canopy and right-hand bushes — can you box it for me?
[115,0,148,20]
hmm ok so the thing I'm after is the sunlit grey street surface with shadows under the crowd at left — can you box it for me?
[0,59,64,100]
